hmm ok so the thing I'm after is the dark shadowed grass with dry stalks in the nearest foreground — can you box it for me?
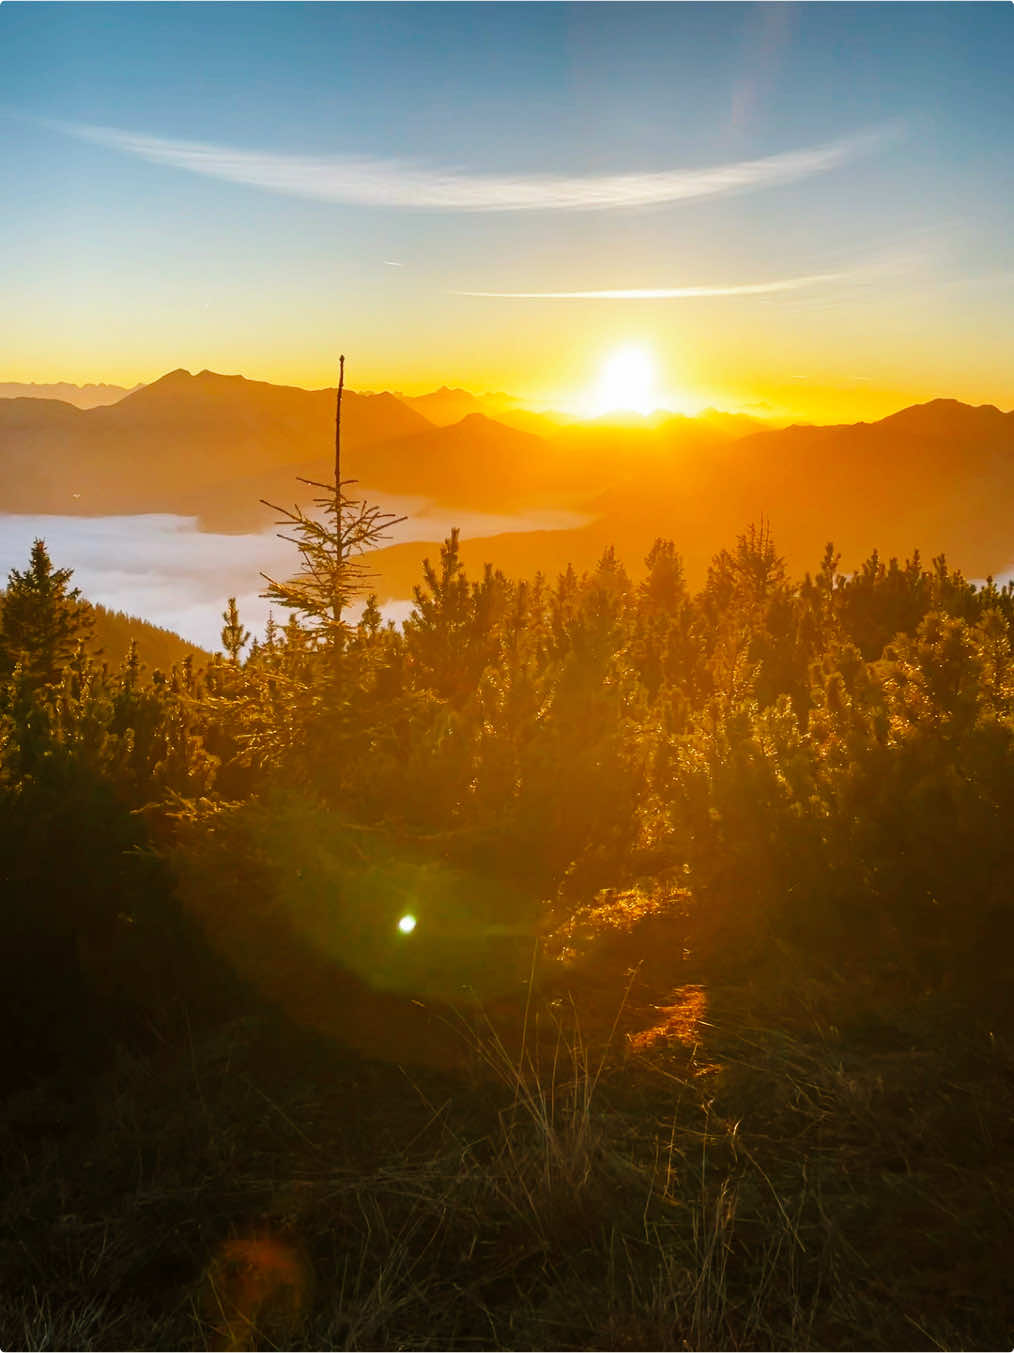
[0,957,1014,1349]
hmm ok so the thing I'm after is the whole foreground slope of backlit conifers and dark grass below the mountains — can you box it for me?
[0,525,1014,1348]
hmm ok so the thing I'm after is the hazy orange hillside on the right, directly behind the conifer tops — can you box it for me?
[584,399,1014,576]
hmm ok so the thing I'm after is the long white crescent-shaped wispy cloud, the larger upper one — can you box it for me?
[49,122,900,211]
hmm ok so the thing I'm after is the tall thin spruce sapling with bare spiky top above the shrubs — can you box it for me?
[261,354,405,652]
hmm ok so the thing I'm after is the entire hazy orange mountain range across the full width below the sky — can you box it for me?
[0,369,1014,598]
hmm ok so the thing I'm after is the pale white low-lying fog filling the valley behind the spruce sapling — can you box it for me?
[0,494,588,649]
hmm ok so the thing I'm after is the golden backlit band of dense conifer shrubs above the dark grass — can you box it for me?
[0,524,1014,1022]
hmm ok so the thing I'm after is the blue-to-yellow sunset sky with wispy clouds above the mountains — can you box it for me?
[0,0,1014,422]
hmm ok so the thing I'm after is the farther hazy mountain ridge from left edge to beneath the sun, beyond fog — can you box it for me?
[0,369,758,530]
